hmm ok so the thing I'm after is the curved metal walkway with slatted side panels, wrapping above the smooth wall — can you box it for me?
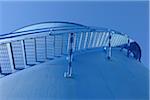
[0,22,141,74]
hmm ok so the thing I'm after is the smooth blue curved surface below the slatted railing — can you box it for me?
[0,49,149,100]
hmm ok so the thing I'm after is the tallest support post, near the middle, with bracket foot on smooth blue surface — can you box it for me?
[64,33,74,78]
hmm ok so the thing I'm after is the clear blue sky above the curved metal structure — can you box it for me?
[0,1,149,67]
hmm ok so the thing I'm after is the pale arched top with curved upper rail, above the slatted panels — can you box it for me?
[0,21,131,40]
